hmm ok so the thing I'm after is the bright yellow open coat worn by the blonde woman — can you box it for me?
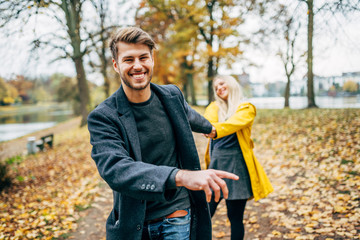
[204,102,274,201]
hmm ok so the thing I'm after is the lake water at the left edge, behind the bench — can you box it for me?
[0,106,73,142]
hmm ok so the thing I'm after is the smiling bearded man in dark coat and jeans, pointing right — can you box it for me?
[88,27,238,240]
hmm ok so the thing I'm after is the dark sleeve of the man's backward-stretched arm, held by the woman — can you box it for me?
[173,85,212,133]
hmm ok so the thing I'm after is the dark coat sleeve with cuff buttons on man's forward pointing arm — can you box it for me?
[88,110,178,201]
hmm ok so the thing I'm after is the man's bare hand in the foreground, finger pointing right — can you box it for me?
[175,169,239,202]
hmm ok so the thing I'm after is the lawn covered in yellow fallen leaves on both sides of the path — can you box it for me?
[0,108,360,239]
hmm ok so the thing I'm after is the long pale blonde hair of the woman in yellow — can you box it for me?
[213,75,244,122]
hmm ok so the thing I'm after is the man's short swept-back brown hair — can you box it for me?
[110,27,156,61]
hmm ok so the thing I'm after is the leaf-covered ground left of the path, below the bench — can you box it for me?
[0,128,99,239]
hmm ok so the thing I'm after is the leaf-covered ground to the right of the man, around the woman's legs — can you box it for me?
[213,109,360,239]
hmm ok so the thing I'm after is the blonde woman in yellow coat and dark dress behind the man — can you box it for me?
[204,76,273,240]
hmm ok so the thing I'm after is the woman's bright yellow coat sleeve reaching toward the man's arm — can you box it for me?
[213,103,256,138]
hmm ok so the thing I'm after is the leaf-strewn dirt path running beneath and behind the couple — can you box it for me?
[69,134,269,240]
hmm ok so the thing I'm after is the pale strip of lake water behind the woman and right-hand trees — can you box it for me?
[198,95,360,109]
